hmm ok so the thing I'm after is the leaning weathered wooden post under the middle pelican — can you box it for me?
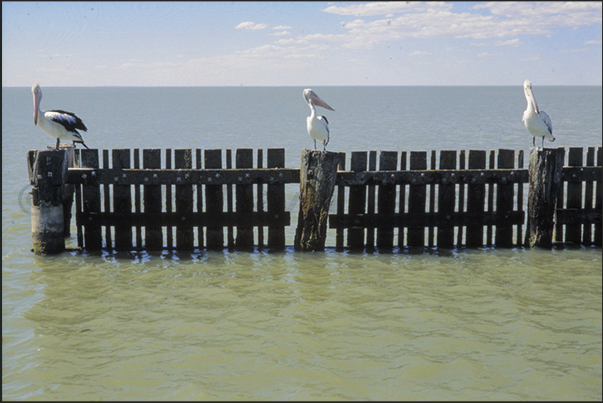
[295,149,339,251]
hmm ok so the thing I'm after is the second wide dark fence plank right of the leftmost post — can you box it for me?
[112,148,132,250]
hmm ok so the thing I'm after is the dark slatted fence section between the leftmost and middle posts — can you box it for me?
[68,149,299,250]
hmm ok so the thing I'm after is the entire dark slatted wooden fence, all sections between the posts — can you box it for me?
[28,147,602,250]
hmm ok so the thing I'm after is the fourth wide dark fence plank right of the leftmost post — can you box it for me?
[174,149,194,250]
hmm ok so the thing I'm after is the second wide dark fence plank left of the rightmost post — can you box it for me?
[465,150,486,248]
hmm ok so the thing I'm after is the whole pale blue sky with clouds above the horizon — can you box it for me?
[2,1,602,87]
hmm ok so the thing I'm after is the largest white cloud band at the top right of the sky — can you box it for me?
[323,2,601,49]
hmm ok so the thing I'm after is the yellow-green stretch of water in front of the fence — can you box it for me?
[3,249,601,400]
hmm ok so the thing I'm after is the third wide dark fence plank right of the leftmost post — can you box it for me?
[142,148,163,250]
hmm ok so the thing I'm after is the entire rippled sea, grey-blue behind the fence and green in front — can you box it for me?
[2,85,602,400]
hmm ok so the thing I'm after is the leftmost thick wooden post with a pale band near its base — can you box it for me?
[27,149,69,255]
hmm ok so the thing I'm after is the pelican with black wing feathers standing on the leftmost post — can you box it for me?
[31,84,88,149]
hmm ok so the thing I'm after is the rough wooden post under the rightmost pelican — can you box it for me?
[526,148,564,248]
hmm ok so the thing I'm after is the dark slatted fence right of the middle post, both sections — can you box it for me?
[330,147,602,250]
